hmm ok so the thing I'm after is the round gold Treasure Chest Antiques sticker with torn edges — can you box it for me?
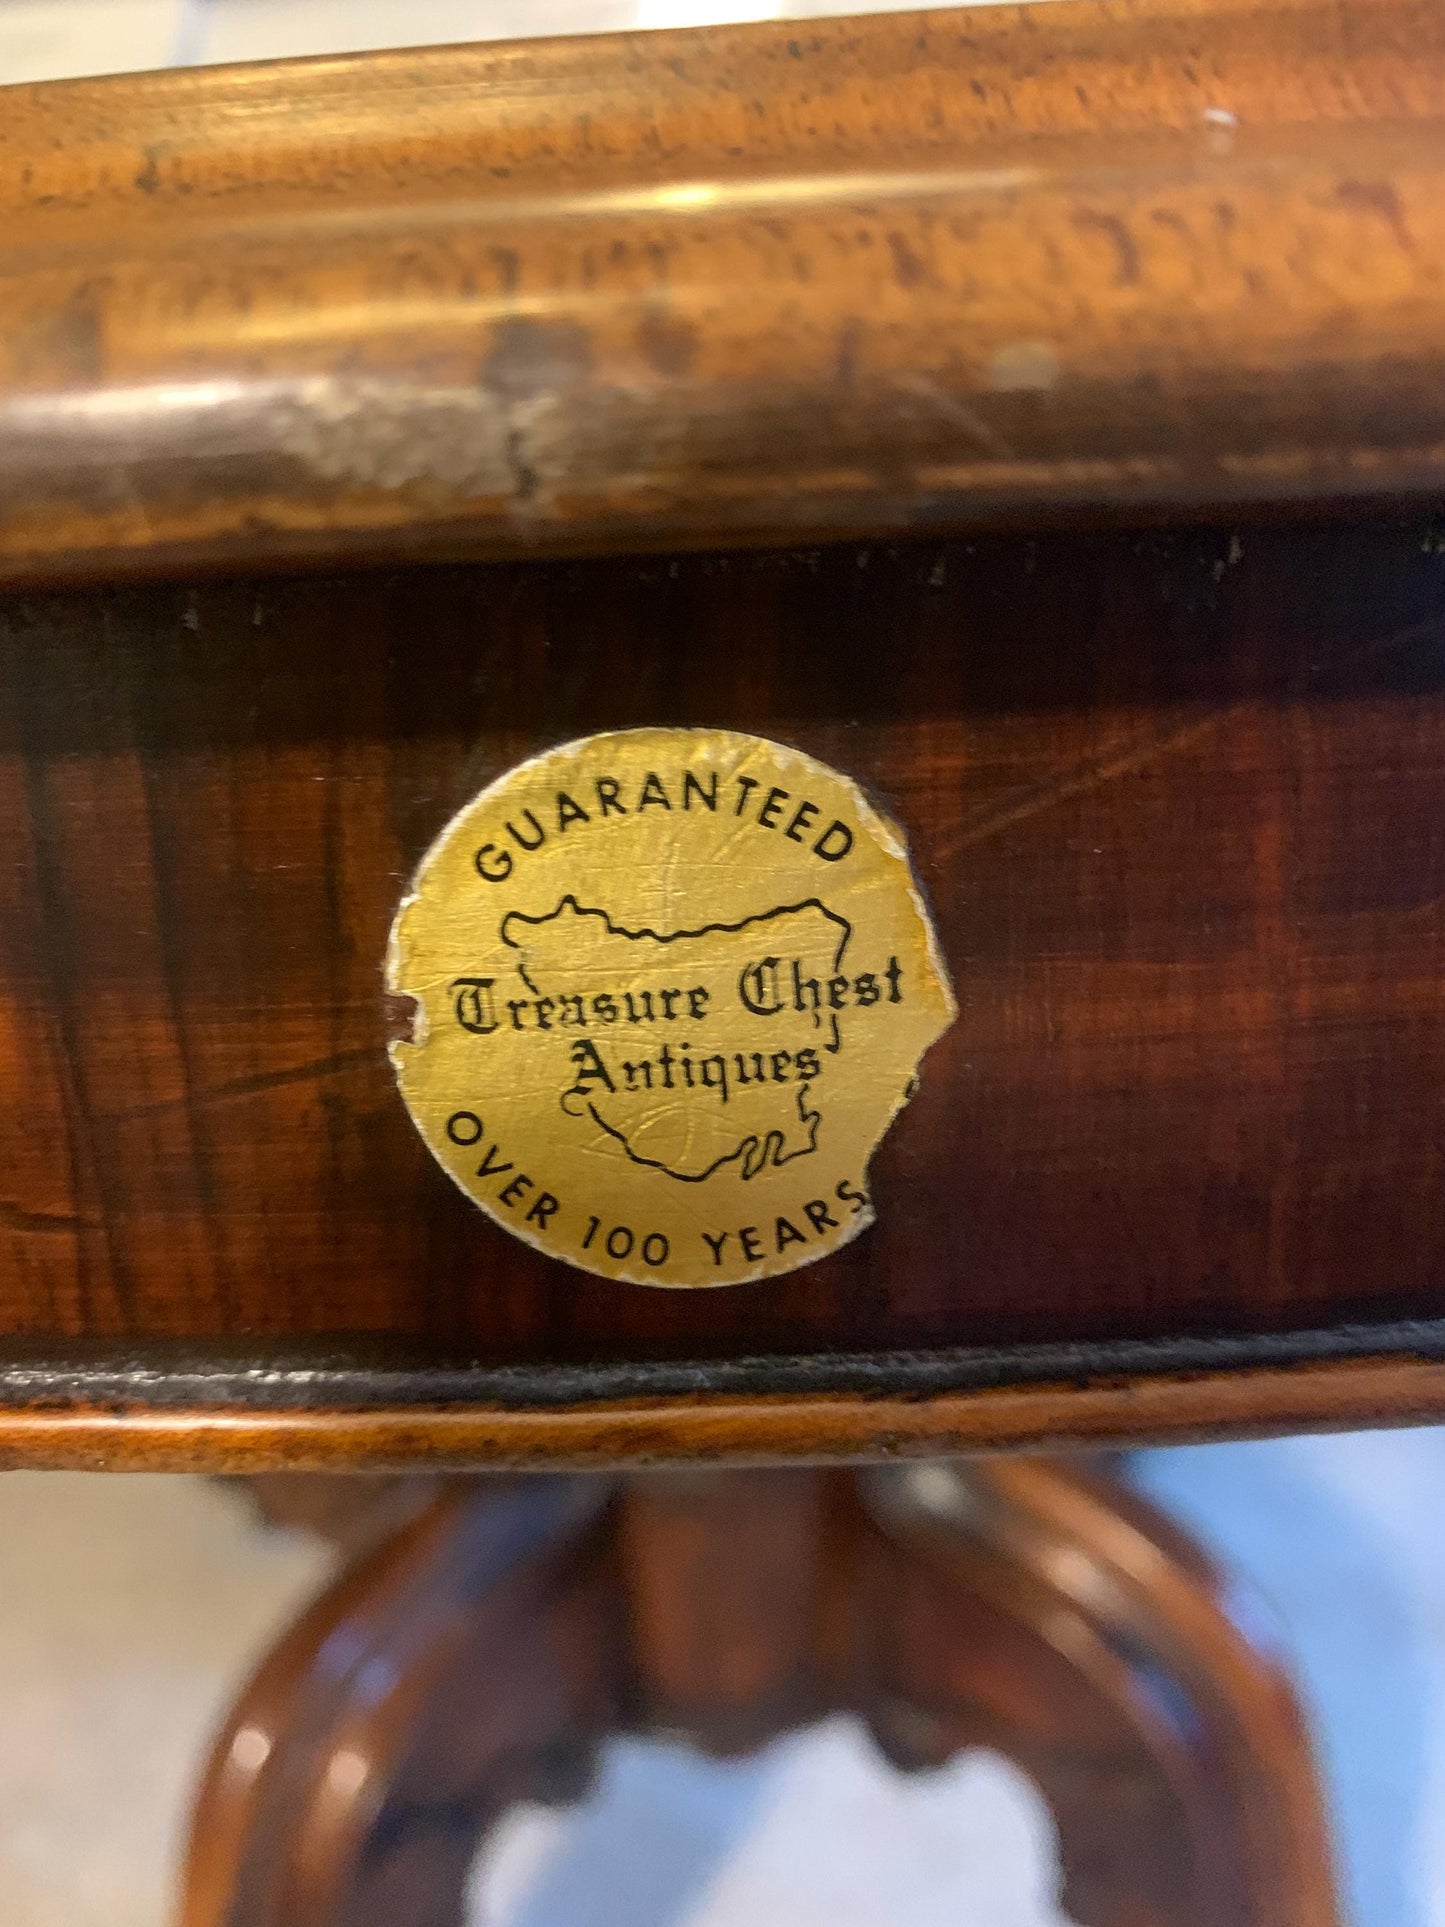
[387,728,954,1285]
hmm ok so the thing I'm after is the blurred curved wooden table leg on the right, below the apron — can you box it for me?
[857,1459,1337,1927]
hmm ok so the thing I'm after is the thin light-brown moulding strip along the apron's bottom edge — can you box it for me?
[0,1359,1445,1472]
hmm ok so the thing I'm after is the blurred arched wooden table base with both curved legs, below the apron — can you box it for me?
[181,1461,1337,1927]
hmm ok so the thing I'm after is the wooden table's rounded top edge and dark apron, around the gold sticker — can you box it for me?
[0,0,1445,1911]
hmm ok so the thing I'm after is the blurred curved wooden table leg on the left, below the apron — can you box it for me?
[181,1478,620,1927]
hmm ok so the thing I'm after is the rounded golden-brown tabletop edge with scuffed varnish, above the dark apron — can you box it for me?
[0,0,1445,580]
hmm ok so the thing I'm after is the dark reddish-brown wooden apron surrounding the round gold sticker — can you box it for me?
[0,515,1445,1465]
